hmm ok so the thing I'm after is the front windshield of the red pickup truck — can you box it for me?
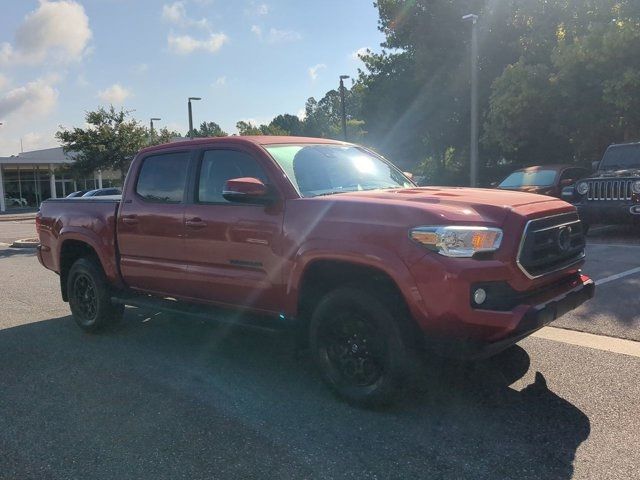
[265,144,415,197]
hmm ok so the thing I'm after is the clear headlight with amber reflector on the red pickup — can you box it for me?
[409,226,502,257]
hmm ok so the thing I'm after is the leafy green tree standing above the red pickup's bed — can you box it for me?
[56,106,149,178]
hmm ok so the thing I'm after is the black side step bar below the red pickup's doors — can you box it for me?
[111,295,294,332]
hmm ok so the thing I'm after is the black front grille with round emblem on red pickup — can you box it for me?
[518,212,585,278]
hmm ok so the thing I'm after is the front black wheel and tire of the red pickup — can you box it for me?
[309,287,411,407]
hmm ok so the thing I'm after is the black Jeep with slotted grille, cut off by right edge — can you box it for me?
[563,143,640,232]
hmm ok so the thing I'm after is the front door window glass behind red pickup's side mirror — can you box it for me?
[197,150,268,203]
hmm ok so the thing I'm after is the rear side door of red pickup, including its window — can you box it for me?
[117,151,191,296]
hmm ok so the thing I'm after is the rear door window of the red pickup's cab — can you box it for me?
[136,152,191,203]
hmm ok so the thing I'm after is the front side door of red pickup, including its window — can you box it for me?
[179,148,283,312]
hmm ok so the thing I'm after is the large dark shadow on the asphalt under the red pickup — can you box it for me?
[0,309,590,479]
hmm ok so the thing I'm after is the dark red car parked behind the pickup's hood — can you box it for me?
[497,165,591,198]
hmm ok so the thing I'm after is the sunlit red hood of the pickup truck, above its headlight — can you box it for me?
[315,187,571,225]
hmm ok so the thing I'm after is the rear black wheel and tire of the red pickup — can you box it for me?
[67,258,124,333]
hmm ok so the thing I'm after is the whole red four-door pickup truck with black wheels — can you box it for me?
[37,137,594,404]
